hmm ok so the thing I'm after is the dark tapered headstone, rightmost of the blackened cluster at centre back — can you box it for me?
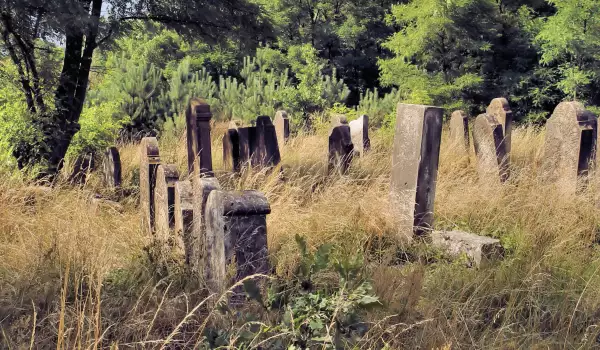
[252,116,281,167]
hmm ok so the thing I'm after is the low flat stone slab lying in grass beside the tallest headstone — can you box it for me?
[431,231,504,267]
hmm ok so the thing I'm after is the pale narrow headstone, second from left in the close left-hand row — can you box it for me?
[154,164,179,242]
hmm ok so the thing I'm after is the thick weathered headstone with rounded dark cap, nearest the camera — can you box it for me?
[204,191,271,293]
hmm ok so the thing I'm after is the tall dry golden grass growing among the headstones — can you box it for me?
[0,125,600,349]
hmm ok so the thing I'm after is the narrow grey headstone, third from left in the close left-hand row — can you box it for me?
[175,181,194,266]
